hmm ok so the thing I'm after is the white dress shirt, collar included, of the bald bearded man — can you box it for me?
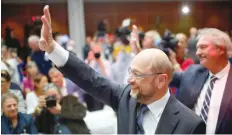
[143,90,170,134]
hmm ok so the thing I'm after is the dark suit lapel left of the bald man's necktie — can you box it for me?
[129,98,137,134]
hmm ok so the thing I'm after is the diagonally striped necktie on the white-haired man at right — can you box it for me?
[200,75,217,123]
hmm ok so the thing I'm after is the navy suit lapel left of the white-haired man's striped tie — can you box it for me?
[190,68,209,108]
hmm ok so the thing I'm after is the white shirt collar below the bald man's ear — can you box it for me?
[147,90,170,118]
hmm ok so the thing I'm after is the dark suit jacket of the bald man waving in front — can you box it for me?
[60,54,205,134]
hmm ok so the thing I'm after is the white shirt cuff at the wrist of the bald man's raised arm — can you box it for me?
[46,43,69,67]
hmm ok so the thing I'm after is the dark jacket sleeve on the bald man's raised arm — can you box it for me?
[59,53,124,110]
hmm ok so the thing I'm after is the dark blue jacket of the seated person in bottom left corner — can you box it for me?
[1,112,38,134]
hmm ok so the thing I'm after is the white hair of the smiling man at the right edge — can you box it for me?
[198,28,232,57]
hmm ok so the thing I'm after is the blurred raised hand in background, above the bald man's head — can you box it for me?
[130,25,141,54]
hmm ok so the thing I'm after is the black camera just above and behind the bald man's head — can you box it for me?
[160,30,178,56]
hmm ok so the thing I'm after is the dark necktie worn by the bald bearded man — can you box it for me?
[137,104,149,134]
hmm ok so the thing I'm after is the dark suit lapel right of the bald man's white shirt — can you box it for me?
[155,95,179,134]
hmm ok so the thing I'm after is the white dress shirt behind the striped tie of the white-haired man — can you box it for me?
[194,62,230,134]
